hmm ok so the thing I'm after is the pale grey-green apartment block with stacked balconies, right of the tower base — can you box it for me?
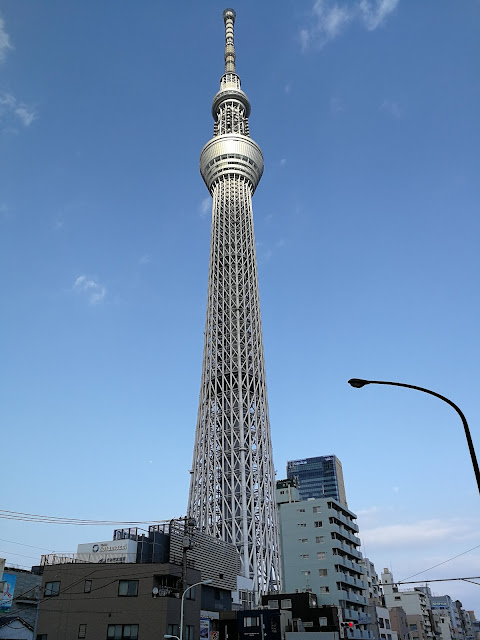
[277,479,373,639]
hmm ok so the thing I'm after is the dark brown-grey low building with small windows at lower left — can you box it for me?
[37,563,202,640]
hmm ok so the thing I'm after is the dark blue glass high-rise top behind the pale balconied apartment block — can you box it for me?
[287,456,348,507]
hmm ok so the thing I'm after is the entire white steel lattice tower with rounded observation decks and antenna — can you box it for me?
[188,9,280,598]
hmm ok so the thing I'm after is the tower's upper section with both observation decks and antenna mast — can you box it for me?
[200,9,263,193]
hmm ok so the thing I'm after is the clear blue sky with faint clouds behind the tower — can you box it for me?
[0,0,480,615]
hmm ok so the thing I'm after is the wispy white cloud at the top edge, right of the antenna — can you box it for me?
[300,0,399,51]
